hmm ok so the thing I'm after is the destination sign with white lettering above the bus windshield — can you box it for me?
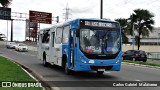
[80,20,118,28]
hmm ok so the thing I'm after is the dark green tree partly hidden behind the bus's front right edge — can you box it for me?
[115,18,129,43]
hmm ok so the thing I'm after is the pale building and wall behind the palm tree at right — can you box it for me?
[123,27,160,59]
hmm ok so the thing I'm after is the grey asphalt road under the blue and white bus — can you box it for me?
[0,45,160,90]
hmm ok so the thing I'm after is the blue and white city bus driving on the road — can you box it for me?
[38,18,122,74]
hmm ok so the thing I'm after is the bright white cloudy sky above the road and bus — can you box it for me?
[0,0,160,41]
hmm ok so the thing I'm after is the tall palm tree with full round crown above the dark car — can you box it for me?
[129,9,154,50]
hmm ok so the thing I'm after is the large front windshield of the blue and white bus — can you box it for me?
[80,28,120,54]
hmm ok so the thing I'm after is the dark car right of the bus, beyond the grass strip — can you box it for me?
[123,50,147,62]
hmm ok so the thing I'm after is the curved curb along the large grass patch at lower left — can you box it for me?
[0,55,54,90]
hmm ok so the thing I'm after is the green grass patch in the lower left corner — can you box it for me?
[0,56,43,90]
